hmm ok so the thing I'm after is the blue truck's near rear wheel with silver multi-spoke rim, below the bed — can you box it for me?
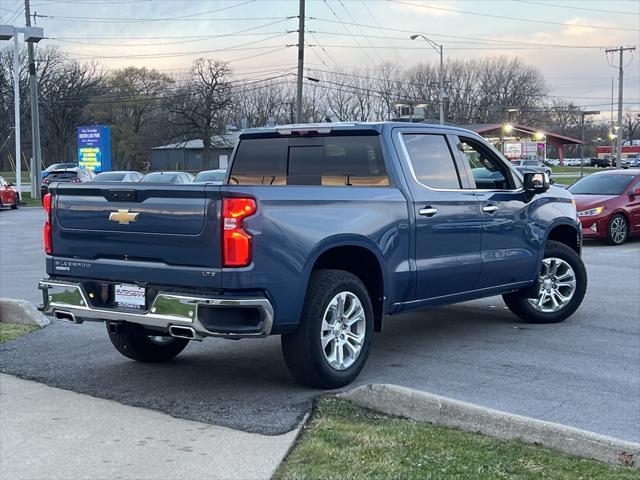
[282,270,373,389]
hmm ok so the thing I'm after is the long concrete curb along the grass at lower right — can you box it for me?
[339,384,640,468]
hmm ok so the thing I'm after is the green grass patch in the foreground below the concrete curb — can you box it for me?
[274,397,638,480]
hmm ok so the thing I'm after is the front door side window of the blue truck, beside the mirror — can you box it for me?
[458,137,521,190]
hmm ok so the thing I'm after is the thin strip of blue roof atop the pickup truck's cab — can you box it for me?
[240,121,475,138]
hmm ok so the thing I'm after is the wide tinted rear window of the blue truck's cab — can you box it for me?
[229,136,389,186]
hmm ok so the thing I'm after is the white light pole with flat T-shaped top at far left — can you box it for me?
[0,25,44,196]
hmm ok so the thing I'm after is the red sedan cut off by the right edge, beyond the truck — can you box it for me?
[567,168,640,245]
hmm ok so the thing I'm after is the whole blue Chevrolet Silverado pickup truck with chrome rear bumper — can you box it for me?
[39,122,587,388]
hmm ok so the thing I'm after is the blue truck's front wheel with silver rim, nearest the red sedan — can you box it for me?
[502,240,587,323]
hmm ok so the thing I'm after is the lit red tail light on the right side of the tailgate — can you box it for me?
[222,198,257,267]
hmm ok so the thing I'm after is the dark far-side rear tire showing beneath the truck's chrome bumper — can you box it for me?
[107,325,189,363]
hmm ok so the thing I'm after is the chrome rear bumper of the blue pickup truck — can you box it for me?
[38,279,274,340]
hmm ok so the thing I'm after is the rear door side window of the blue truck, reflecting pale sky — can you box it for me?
[402,134,460,188]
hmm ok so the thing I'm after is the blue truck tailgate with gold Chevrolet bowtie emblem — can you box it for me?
[48,183,221,288]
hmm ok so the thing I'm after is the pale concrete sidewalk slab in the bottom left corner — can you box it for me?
[0,374,297,480]
